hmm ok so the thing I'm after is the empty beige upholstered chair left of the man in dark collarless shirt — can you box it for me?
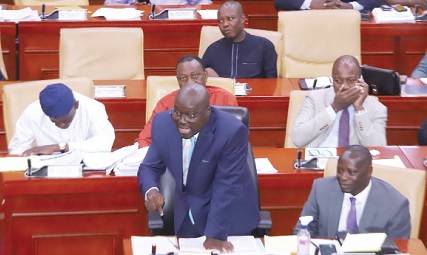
[59,27,145,80]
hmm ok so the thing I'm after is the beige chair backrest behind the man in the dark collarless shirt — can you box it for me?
[199,26,282,73]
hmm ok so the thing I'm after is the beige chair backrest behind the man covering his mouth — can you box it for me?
[284,90,307,148]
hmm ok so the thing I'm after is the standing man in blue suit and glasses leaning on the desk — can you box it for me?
[138,84,260,252]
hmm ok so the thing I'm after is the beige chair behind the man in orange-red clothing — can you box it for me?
[145,75,234,121]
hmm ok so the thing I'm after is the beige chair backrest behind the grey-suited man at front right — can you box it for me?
[324,158,426,238]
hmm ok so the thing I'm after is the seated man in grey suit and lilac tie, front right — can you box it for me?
[294,145,411,238]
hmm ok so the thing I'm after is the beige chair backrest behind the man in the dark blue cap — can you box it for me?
[3,77,93,143]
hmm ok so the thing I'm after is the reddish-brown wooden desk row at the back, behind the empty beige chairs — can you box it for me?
[9,4,427,80]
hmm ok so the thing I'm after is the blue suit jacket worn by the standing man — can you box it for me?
[138,107,260,240]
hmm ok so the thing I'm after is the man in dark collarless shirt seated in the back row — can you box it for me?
[202,1,277,78]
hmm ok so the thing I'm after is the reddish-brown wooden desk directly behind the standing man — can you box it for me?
[0,146,427,255]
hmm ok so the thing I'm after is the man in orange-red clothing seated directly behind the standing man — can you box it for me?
[135,55,237,148]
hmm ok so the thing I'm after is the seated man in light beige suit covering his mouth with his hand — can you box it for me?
[291,55,387,147]
